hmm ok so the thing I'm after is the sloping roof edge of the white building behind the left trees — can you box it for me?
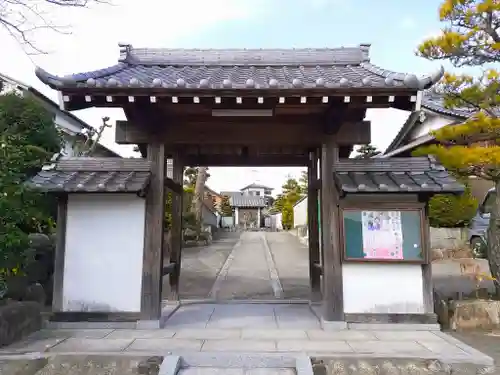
[0,73,121,157]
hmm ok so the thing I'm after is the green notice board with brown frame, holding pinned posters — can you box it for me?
[341,207,427,264]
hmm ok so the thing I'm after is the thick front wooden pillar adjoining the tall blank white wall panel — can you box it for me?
[141,143,166,321]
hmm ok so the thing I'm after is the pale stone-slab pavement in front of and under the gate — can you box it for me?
[0,303,492,365]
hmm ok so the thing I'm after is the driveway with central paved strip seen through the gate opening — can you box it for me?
[180,232,309,300]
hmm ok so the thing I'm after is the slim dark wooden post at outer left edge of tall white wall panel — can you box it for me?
[52,195,68,312]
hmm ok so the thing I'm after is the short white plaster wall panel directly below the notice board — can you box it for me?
[342,263,424,314]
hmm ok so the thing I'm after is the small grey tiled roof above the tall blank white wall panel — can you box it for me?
[28,157,151,193]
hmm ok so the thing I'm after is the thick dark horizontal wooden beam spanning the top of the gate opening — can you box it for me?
[115,117,371,146]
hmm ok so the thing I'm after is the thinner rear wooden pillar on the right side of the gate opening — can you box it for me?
[307,150,321,301]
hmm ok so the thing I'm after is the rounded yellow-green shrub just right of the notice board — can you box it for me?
[429,184,478,228]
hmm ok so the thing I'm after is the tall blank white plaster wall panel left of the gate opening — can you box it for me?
[63,194,145,312]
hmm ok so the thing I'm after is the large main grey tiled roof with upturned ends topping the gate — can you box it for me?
[36,44,444,91]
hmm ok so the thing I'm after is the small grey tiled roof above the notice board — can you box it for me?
[334,157,464,194]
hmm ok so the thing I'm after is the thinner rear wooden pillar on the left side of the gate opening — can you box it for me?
[169,154,184,301]
